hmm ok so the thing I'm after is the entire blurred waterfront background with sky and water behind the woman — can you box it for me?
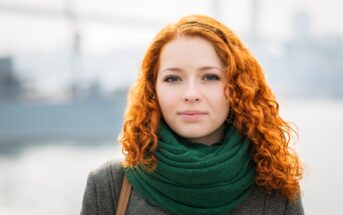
[0,0,343,215]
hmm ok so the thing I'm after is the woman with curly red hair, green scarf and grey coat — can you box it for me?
[81,15,304,214]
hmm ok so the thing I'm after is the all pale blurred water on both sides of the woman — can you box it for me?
[0,100,343,215]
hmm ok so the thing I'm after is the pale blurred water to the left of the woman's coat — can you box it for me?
[0,143,120,215]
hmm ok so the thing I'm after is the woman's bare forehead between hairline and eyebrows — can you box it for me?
[159,36,222,69]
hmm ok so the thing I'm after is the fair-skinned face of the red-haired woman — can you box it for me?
[156,36,229,144]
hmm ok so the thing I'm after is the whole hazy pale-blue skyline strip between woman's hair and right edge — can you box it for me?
[247,9,343,98]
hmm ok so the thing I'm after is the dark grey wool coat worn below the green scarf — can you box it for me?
[80,160,304,215]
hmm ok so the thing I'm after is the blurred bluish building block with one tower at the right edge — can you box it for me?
[283,10,343,97]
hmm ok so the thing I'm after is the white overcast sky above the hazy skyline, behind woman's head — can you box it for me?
[0,0,343,55]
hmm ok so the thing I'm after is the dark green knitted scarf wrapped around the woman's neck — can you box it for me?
[124,120,256,215]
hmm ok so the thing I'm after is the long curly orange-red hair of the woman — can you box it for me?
[118,15,303,200]
